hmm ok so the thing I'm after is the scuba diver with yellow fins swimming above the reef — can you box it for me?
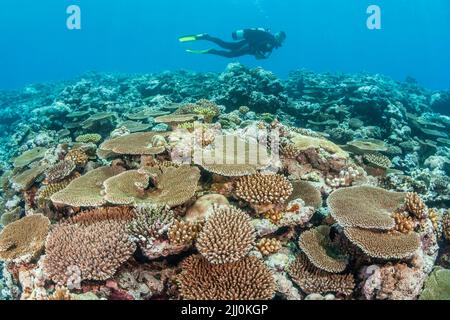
[178,28,286,60]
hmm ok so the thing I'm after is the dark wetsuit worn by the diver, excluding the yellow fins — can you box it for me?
[201,29,277,59]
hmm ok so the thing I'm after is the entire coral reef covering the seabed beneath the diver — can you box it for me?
[0,63,450,300]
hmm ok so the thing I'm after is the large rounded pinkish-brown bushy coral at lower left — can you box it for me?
[44,212,135,285]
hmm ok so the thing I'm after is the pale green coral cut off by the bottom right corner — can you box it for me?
[419,267,450,300]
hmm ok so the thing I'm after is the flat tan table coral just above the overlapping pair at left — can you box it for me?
[99,132,166,157]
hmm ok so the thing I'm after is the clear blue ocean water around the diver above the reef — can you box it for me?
[0,0,450,89]
